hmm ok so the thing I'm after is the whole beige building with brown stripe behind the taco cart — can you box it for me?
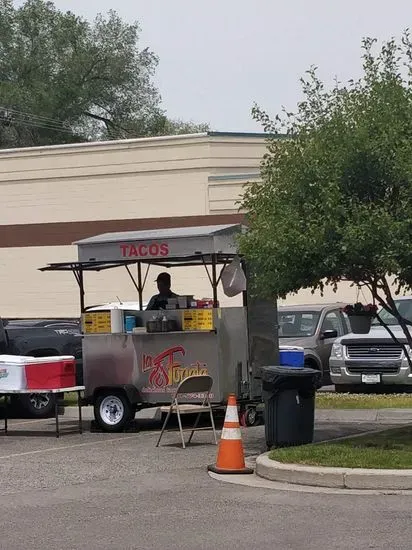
[0,133,370,317]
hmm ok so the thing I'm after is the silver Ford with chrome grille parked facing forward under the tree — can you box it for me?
[329,296,412,391]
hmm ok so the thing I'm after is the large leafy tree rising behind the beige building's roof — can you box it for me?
[0,0,206,147]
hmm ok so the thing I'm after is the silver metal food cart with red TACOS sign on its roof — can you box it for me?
[41,224,279,432]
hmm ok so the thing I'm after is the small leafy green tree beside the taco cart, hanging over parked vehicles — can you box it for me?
[241,32,412,358]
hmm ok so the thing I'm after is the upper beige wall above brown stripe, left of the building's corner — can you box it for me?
[0,137,209,224]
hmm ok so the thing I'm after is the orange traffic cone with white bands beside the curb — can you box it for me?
[207,394,253,474]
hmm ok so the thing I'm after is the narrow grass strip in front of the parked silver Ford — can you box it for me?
[316,392,412,409]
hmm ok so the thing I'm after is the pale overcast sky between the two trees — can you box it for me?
[33,0,412,132]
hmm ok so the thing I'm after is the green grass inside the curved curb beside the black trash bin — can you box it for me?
[269,426,412,469]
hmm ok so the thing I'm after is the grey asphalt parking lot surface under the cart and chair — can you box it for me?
[0,417,412,550]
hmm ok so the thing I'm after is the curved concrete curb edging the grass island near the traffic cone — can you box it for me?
[256,453,412,490]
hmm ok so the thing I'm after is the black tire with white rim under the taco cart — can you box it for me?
[94,392,134,432]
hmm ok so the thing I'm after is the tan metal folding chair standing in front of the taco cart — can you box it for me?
[156,374,217,449]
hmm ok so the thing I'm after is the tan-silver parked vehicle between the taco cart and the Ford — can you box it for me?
[278,303,350,384]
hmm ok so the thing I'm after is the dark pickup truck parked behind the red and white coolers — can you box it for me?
[0,319,82,418]
